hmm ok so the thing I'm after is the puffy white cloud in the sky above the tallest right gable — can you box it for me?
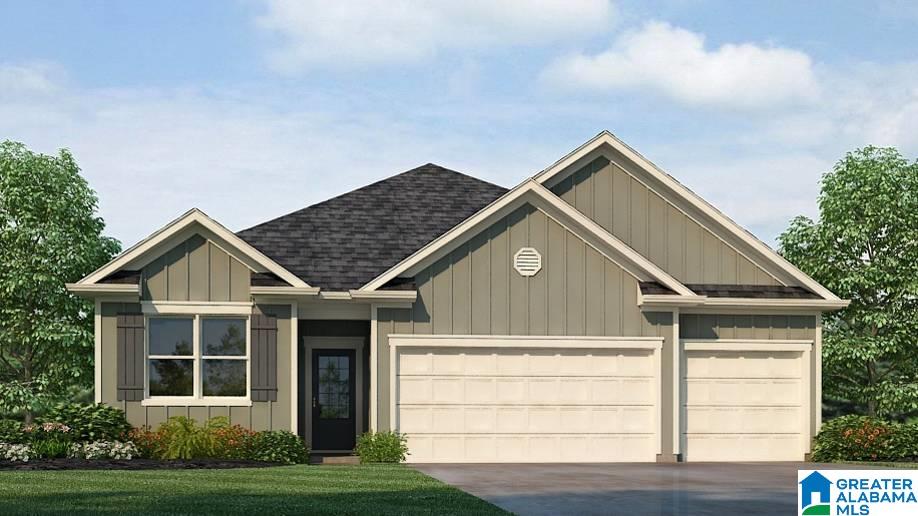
[543,22,819,109]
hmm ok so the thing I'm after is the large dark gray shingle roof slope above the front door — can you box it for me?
[237,163,507,290]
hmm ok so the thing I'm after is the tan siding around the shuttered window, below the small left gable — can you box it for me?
[101,303,292,430]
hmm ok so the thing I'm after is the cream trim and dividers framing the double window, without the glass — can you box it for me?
[140,309,252,407]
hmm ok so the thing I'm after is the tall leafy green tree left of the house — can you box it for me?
[0,141,120,420]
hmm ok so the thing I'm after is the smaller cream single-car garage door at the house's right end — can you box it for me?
[682,343,809,461]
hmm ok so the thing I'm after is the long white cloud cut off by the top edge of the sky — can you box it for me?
[257,0,615,72]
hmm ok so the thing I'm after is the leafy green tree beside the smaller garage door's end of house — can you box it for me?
[779,147,918,418]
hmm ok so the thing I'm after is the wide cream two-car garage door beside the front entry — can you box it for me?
[390,338,660,462]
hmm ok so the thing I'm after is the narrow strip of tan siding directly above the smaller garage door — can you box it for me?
[679,314,816,340]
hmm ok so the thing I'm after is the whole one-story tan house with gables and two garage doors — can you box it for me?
[68,132,846,462]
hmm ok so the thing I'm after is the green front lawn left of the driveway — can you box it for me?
[0,465,507,516]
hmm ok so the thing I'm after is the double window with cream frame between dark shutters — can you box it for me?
[146,315,250,402]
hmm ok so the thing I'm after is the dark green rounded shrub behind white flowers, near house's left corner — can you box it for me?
[42,403,131,442]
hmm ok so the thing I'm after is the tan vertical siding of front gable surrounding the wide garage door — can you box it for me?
[376,204,674,454]
